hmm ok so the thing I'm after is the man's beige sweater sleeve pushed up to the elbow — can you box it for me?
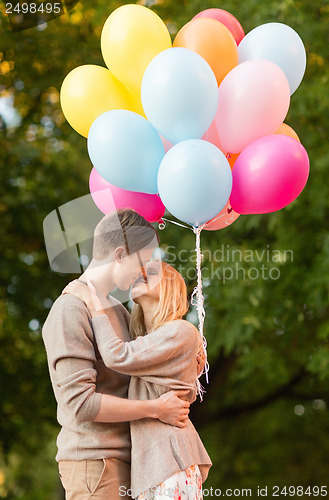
[42,305,102,422]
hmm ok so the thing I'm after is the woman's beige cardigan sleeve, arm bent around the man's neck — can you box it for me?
[92,314,198,376]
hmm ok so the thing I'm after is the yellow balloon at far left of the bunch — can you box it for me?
[60,64,132,137]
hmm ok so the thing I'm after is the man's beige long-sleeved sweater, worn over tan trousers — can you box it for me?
[42,294,131,462]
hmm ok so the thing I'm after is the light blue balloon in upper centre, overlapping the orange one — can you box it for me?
[141,47,218,144]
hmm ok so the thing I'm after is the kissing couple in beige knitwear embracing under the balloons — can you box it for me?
[42,209,212,500]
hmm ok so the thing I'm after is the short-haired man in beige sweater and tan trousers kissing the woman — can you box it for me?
[42,209,204,500]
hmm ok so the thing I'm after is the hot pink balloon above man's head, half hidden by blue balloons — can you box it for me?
[89,168,165,222]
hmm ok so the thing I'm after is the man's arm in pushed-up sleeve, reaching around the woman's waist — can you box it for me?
[43,298,189,427]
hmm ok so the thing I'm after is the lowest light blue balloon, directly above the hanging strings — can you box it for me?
[158,139,232,226]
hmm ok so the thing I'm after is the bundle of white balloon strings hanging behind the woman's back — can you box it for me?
[191,224,209,401]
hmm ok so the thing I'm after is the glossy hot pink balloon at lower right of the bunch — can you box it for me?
[230,135,310,214]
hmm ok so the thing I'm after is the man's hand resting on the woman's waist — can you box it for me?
[154,389,190,428]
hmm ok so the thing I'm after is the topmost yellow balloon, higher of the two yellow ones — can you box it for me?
[101,4,172,92]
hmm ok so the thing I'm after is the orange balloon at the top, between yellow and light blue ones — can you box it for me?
[173,17,239,85]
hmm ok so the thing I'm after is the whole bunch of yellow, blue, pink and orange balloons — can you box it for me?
[60,4,309,230]
